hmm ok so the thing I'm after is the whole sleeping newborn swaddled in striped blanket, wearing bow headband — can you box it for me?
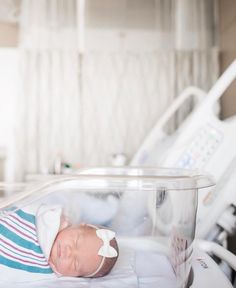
[0,205,118,281]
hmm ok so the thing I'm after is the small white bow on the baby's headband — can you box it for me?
[96,229,118,258]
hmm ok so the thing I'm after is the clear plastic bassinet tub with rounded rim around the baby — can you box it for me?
[0,168,213,288]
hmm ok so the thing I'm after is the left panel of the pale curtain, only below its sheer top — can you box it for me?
[15,50,81,180]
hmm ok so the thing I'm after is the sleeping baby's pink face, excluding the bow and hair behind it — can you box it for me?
[49,225,102,276]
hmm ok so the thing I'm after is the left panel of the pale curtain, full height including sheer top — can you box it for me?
[14,0,81,180]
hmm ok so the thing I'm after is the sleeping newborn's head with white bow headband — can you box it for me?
[49,220,118,277]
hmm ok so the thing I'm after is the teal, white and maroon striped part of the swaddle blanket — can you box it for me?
[0,209,53,274]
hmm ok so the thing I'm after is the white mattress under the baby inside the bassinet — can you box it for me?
[0,247,176,288]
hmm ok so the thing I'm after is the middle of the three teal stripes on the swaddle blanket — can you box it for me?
[0,223,42,254]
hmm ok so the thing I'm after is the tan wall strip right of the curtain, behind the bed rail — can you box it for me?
[219,0,236,118]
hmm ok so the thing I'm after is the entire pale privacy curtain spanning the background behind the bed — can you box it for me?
[12,0,218,179]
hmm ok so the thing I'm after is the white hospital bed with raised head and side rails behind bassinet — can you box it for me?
[130,60,236,246]
